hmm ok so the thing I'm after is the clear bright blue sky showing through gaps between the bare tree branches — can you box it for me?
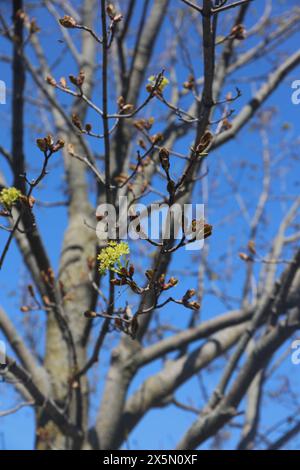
[0,2,300,449]
